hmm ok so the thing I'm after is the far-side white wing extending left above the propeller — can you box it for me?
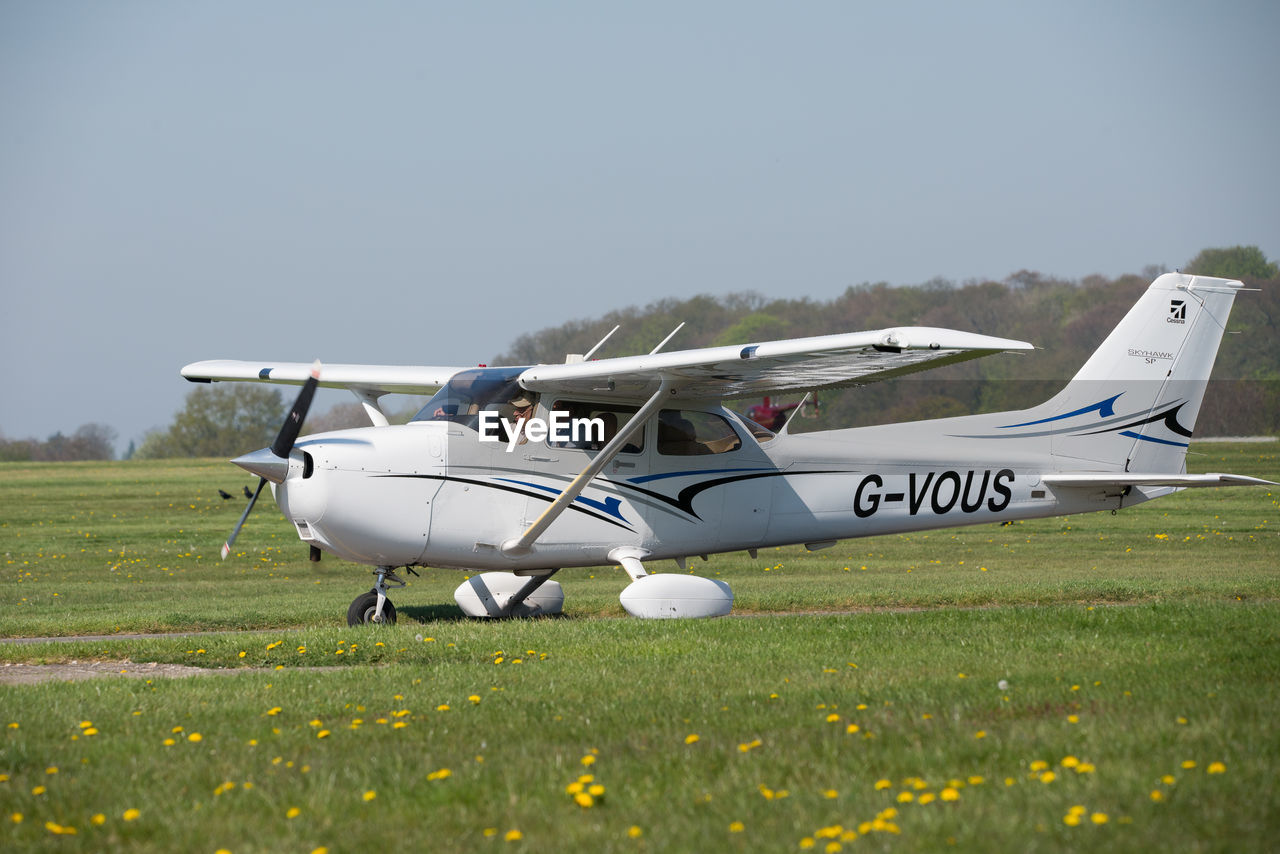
[182,359,466,394]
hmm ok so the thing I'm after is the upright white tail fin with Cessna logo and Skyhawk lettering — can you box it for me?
[1007,273,1244,474]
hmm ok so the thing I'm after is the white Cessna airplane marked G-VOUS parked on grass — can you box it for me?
[182,274,1270,625]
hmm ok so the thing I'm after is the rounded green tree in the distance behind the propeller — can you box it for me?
[134,383,285,460]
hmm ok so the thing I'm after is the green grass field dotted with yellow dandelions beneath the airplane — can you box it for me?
[0,444,1280,854]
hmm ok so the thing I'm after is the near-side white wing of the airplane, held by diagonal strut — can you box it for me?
[520,326,1034,398]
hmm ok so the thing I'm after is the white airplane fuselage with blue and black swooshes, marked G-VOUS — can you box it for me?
[275,401,1141,570]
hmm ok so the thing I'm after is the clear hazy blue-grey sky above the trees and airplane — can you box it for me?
[0,0,1280,449]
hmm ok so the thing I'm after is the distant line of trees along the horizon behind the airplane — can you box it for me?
[35,246,1280,460]
